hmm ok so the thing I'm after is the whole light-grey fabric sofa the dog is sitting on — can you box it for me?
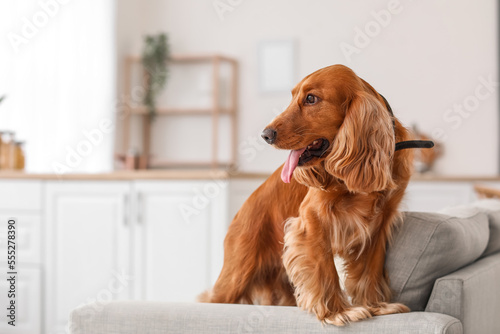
[70,201,500,334]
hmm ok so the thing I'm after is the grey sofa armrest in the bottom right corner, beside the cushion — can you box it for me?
[425,253,500,334]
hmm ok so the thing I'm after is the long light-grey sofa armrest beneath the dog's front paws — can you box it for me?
[70,301,462,334]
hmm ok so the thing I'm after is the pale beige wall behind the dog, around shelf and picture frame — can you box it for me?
[117,0,499,175]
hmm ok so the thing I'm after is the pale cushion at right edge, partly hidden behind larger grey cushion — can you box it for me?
[441,199,500,257]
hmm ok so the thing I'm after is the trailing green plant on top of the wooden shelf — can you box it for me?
[142,33,170,120]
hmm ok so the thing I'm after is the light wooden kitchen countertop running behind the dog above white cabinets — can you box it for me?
[0,169,500,182]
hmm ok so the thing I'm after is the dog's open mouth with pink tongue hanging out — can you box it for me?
[281,138,330,183]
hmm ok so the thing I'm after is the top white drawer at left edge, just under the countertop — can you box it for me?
[0,180,42,211]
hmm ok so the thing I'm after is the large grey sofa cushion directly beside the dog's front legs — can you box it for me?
[385,212,489,311]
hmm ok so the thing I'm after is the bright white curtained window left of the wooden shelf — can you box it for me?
[0,0,116,173]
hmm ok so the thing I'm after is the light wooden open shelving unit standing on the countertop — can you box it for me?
[123,55,238,169]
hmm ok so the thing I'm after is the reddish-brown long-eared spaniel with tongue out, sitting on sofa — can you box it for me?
[199,65,417,326]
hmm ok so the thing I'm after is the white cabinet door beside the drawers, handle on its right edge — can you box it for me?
[44,181,132,334]
